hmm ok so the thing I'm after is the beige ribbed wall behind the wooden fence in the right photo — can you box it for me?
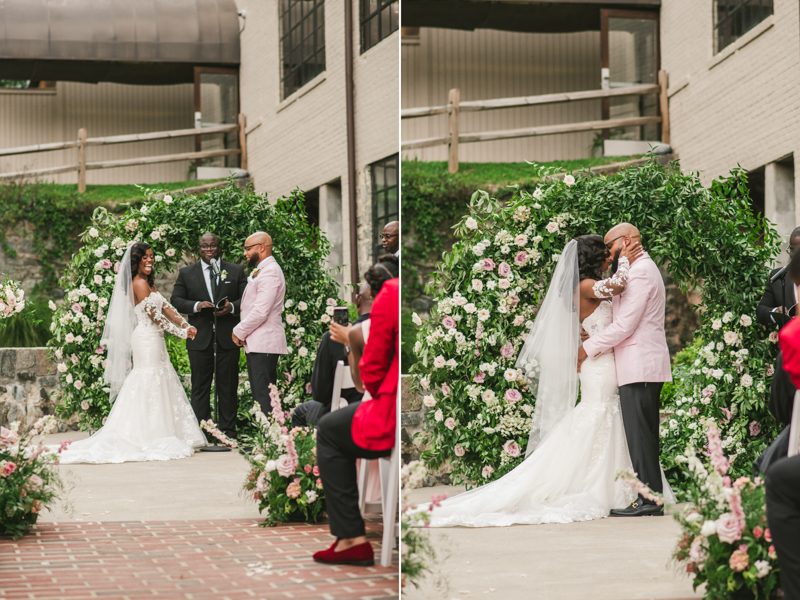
[402,28,601,162]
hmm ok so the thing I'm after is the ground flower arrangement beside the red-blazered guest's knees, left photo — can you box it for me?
[242,385,325,525]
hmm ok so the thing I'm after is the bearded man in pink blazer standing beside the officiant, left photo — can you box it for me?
[231,231,287,413]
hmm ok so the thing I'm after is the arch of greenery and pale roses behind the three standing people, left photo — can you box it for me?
[49,182,338,429]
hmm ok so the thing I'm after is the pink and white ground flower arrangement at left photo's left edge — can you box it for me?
[0,415,69,539]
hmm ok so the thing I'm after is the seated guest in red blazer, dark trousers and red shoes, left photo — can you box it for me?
[314,256,400,566]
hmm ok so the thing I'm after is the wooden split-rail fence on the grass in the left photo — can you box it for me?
[0,114,247,194]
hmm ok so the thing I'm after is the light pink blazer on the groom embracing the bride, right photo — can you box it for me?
[583,252,672,385]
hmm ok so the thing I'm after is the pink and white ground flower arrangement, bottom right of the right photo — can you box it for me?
[673,419,780,600]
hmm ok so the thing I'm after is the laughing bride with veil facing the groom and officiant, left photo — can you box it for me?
[59,242,206,464]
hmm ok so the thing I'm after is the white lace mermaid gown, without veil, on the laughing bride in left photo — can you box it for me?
[59,292,206,464]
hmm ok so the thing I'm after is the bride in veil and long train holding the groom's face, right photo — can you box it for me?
[426,235,668,527]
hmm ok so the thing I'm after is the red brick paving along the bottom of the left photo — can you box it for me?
[0,519,399,600]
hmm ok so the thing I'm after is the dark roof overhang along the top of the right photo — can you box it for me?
[402,0,661,33]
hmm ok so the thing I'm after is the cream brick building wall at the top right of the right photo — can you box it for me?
[661,0,800,233]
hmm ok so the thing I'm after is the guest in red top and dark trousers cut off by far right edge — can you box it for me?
[766,246,800,600]
